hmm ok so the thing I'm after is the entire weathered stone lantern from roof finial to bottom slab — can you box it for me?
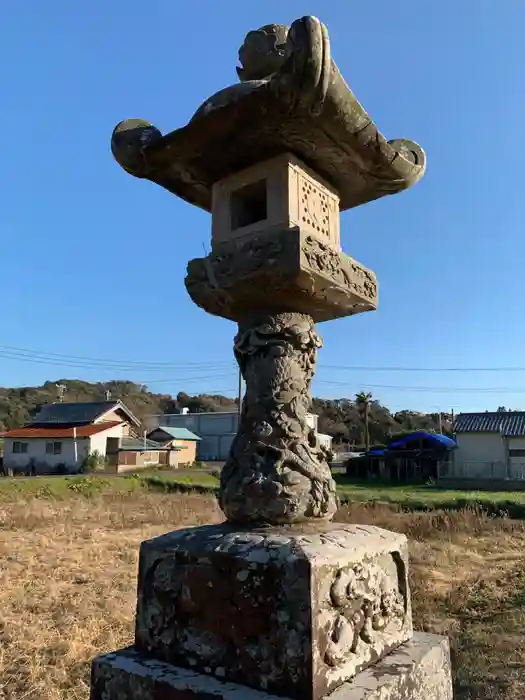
[92,17,451,700]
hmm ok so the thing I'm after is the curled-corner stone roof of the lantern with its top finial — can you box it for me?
[111,17,425,211]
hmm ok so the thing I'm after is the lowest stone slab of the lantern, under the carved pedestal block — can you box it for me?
[91,634,453,700]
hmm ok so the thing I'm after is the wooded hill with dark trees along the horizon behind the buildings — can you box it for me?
[0,379,451,445]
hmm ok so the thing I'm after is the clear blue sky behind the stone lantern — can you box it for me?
[0,0,525,411]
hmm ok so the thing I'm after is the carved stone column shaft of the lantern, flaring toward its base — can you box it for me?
[220,312,337,524]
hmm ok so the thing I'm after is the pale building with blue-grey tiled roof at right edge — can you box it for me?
[447,411,525,481]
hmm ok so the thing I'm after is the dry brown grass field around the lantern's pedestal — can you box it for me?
[0,489,525,700]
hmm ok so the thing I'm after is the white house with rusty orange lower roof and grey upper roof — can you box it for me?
[4,401,140,473]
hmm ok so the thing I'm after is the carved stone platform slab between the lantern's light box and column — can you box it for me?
[185,228,378,323]
